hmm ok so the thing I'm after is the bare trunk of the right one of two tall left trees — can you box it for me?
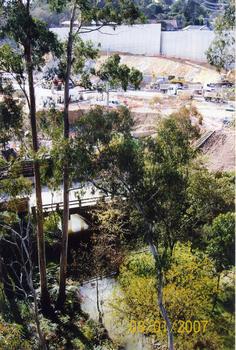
[57,11,74,309]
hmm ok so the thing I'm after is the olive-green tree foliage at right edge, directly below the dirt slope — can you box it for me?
[188,168,235,251]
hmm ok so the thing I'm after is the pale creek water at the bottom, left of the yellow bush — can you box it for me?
[78,278,153,350]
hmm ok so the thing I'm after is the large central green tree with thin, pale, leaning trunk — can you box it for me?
[70,108,203,349]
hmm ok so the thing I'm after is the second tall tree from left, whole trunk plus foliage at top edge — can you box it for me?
[50,0,143,308]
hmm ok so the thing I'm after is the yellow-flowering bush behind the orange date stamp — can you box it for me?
[112,247,233,350]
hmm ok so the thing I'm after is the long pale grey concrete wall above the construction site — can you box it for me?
[51,23,234,61]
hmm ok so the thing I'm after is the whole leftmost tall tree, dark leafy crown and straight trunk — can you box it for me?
[0,0,61,312]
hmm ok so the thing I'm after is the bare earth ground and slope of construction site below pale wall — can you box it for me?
[70,53,235,172]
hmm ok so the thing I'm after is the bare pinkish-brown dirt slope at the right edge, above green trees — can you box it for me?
[201,130,235,172]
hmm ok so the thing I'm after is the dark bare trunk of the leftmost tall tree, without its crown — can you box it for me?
[25,45,50,313]
